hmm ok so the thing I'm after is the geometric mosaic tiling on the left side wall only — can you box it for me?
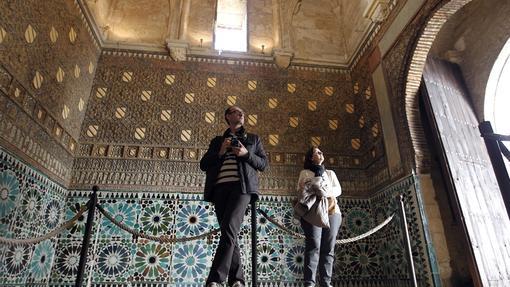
[0,149,67,286]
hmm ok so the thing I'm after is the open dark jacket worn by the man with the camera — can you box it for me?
[200,133,267,202]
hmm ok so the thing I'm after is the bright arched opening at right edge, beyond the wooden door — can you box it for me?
[484,39,510,151]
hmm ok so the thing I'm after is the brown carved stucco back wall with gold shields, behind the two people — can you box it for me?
[72,52,385,194]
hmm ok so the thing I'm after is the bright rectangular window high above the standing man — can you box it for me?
[214,0,248,52]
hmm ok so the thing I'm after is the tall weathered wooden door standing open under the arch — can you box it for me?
[423,57,510,286]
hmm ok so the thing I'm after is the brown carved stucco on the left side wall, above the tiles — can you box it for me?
[0,1,99,184]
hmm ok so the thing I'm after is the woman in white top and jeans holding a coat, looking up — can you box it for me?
[296,147,342,287]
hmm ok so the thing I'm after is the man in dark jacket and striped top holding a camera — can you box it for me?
[200,106,267,287]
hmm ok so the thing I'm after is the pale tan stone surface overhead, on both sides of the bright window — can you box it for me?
[82,0,397,67]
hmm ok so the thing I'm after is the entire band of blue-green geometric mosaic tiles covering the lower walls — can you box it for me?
[0,148,430,286]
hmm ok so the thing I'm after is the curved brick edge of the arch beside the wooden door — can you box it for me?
[404,0,472,173]
